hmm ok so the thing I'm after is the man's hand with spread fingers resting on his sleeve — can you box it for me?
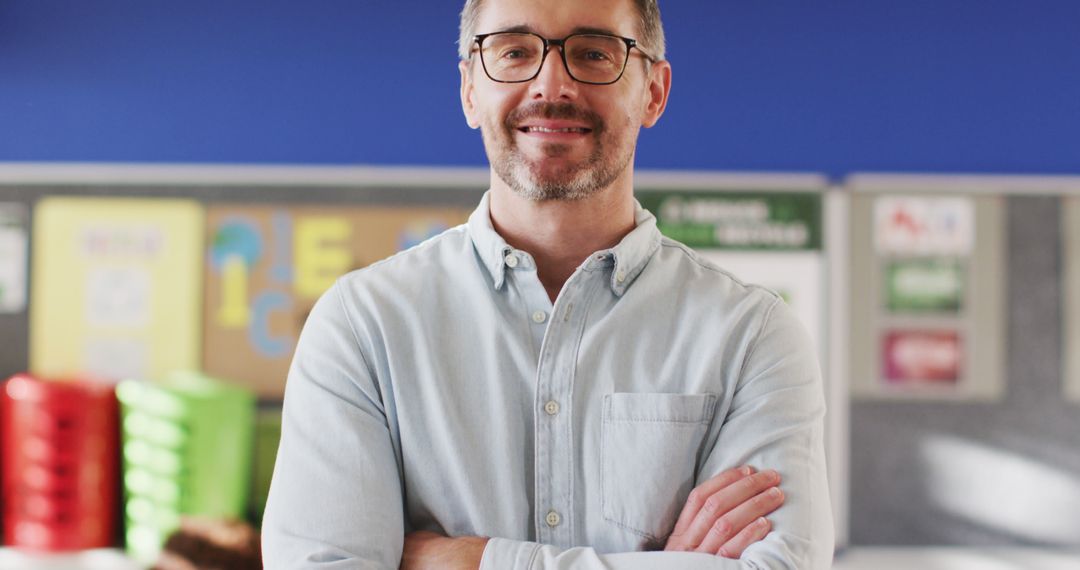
[664,467,784,558]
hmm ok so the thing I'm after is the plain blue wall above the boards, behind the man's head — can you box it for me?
[0,0,1080,175]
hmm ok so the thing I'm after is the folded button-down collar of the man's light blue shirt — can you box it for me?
[468,190,660,297]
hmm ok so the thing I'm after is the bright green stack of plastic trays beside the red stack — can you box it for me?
[117,372,255,564]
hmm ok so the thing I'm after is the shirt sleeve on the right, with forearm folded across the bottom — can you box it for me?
[481,300,834,570]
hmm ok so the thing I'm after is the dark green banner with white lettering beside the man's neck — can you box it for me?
[637,191,822,250]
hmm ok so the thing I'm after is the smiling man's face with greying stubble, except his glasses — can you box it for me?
[461,0,670,201]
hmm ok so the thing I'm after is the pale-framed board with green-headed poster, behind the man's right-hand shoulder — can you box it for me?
[635,173,848,545]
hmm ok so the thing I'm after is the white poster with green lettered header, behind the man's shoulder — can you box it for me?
[638,191,826,358]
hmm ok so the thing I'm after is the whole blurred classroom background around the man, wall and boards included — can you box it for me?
[0,0,1080,568]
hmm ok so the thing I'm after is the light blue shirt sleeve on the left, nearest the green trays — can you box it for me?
[262,284,405,569]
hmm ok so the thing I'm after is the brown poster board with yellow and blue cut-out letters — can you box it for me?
[203,205,470,399]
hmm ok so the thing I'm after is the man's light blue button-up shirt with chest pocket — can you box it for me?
[262,195,833,570]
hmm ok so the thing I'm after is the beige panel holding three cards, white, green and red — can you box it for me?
[850,177,1007,402]
